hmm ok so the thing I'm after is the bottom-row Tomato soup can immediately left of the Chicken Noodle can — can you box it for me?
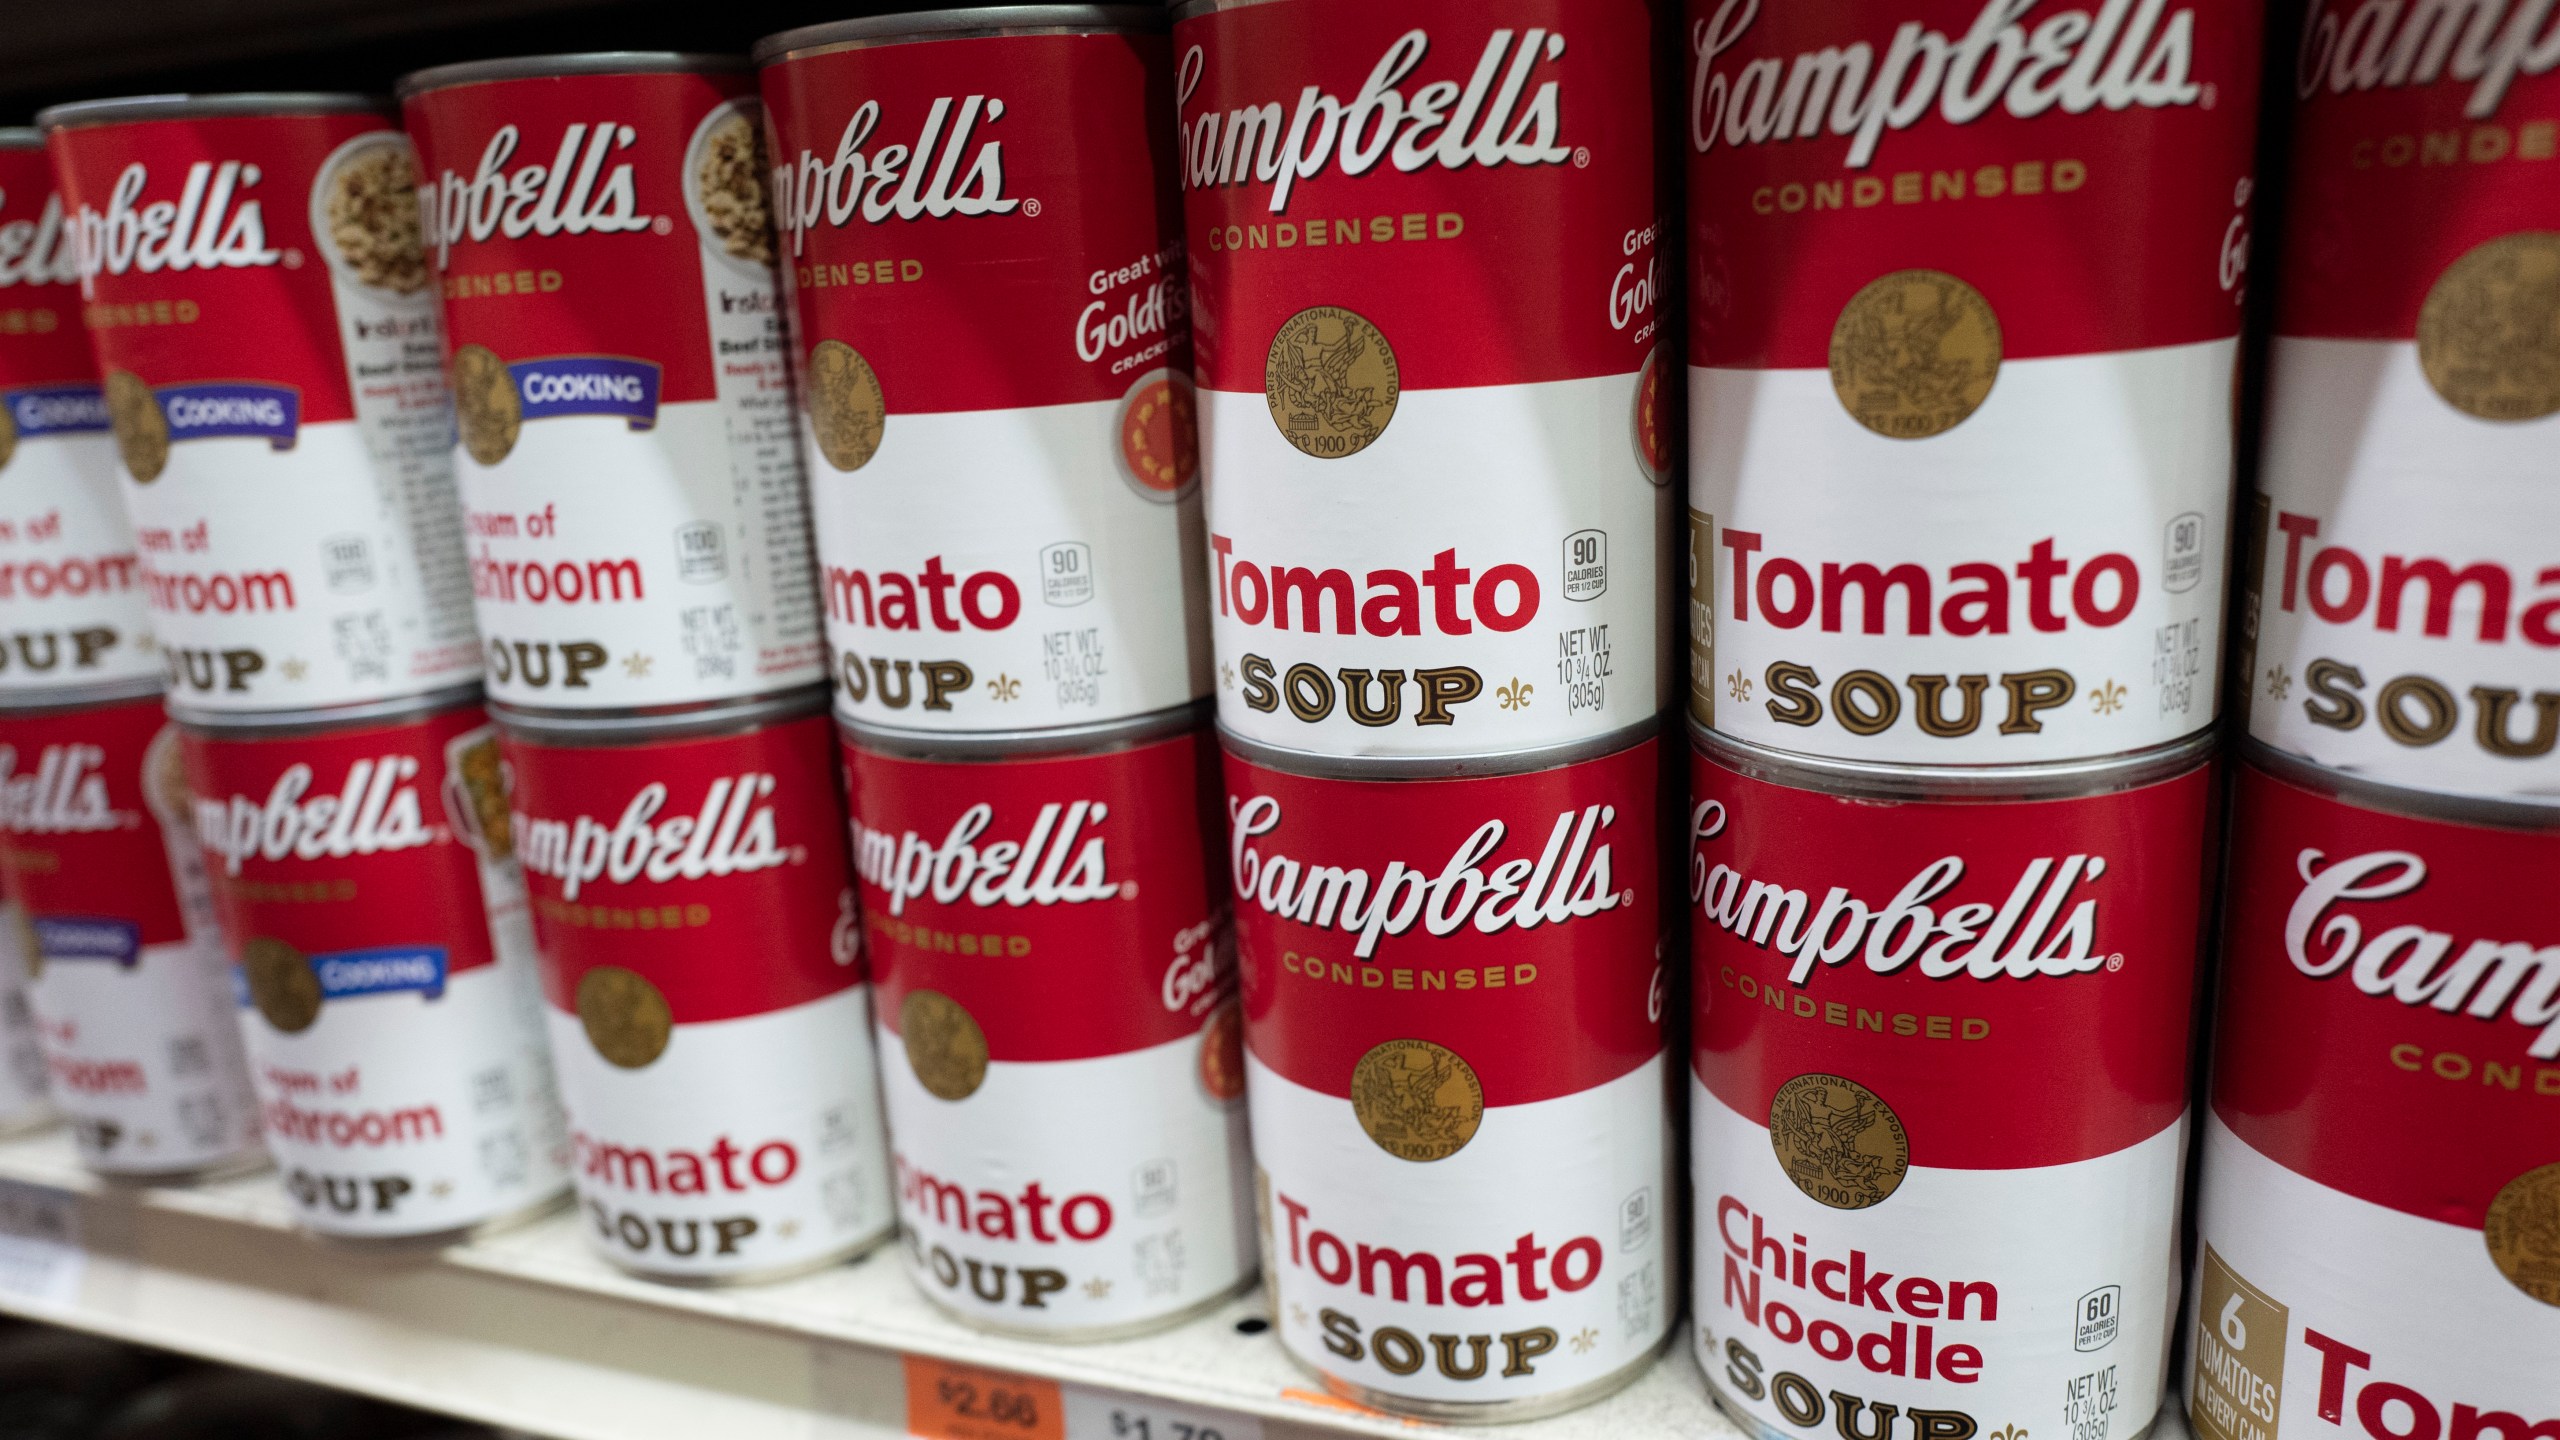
[1226,723,1679,1420]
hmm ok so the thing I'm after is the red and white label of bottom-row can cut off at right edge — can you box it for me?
[2189,769,2560,1440]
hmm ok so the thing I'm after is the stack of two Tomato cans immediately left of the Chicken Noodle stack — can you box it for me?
[1172,0,1679,1420]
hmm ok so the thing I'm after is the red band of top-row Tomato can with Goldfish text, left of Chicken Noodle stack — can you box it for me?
[1172,0,1677,392]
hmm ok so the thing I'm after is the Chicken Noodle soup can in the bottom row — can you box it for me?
[1687,730,2217,1440]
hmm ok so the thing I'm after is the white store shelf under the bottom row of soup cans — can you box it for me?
[0,1133,1741,1440]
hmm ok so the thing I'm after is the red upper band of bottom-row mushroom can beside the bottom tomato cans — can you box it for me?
[184,705,509,974]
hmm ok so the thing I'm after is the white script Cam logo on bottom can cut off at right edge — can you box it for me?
[2284,846,2560,1061]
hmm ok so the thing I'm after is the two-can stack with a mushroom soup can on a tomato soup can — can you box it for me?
[399,51,891,1284]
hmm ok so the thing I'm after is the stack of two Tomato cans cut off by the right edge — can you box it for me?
[2189,0,2560,1440]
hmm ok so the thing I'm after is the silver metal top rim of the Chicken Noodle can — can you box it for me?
[1690,720,2220,805]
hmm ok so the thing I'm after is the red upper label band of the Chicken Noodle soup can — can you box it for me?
[1690,756,2214,1171]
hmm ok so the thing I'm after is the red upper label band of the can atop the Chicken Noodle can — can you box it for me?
[1679,0,2263,369]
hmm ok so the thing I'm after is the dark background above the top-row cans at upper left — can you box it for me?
[0,0,1049,126]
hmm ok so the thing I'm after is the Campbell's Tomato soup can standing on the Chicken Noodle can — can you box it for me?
[1684,0,2263,764]
